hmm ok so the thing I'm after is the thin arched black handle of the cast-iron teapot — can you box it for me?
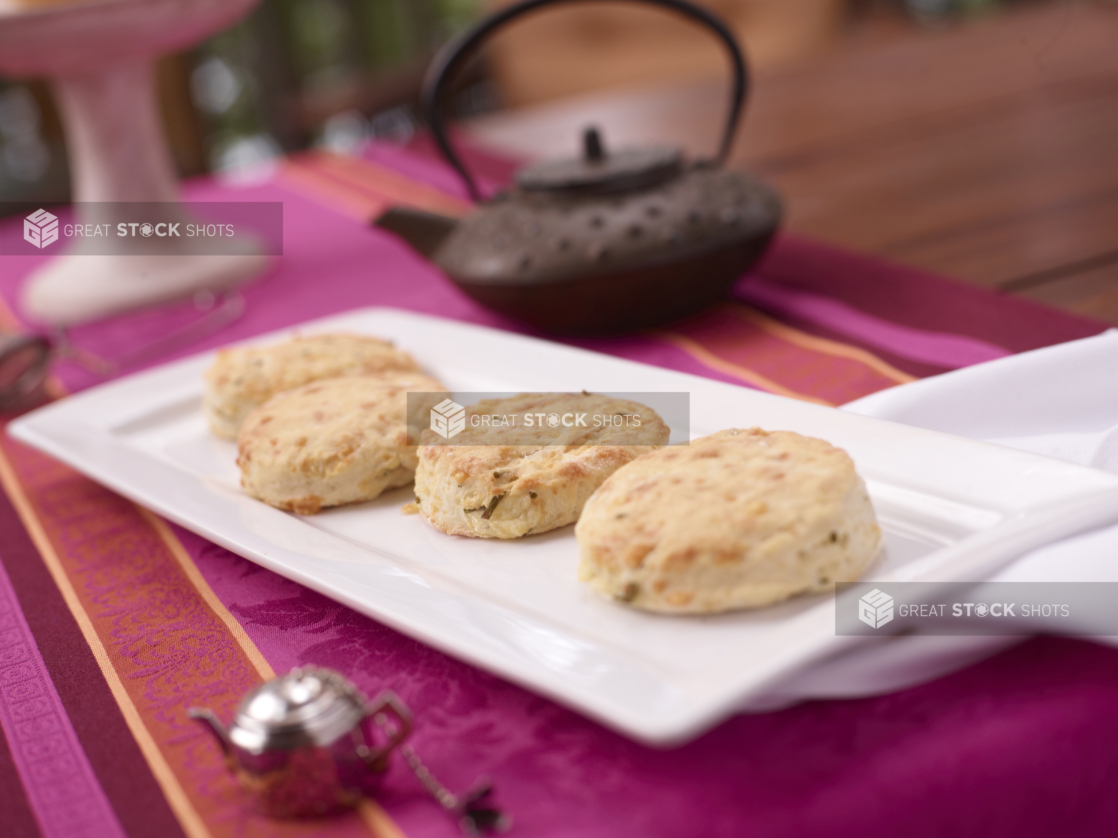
[420,0,749,201]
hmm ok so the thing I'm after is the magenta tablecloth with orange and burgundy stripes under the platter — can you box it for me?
[0,141,1118,838]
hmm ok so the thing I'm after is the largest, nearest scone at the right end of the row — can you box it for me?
[575,428,881,613]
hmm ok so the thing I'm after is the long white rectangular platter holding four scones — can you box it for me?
[10,308,1118,744]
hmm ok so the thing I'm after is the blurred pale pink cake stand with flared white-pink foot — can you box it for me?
[0,0,267,325]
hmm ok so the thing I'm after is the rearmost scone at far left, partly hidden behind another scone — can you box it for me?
[202,333,420,439]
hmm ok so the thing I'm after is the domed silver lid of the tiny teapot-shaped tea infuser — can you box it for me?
[229,667,366,752]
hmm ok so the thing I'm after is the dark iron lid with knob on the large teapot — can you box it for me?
[517,127,683,192]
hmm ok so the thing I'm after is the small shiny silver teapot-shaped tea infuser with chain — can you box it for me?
[188,666,509,835]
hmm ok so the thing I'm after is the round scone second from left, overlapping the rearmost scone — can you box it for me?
[237,372,446,515]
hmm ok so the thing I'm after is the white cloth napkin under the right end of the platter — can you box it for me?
[745,330,1118,711]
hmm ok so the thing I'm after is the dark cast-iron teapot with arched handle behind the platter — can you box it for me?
[376,0,781,334]
